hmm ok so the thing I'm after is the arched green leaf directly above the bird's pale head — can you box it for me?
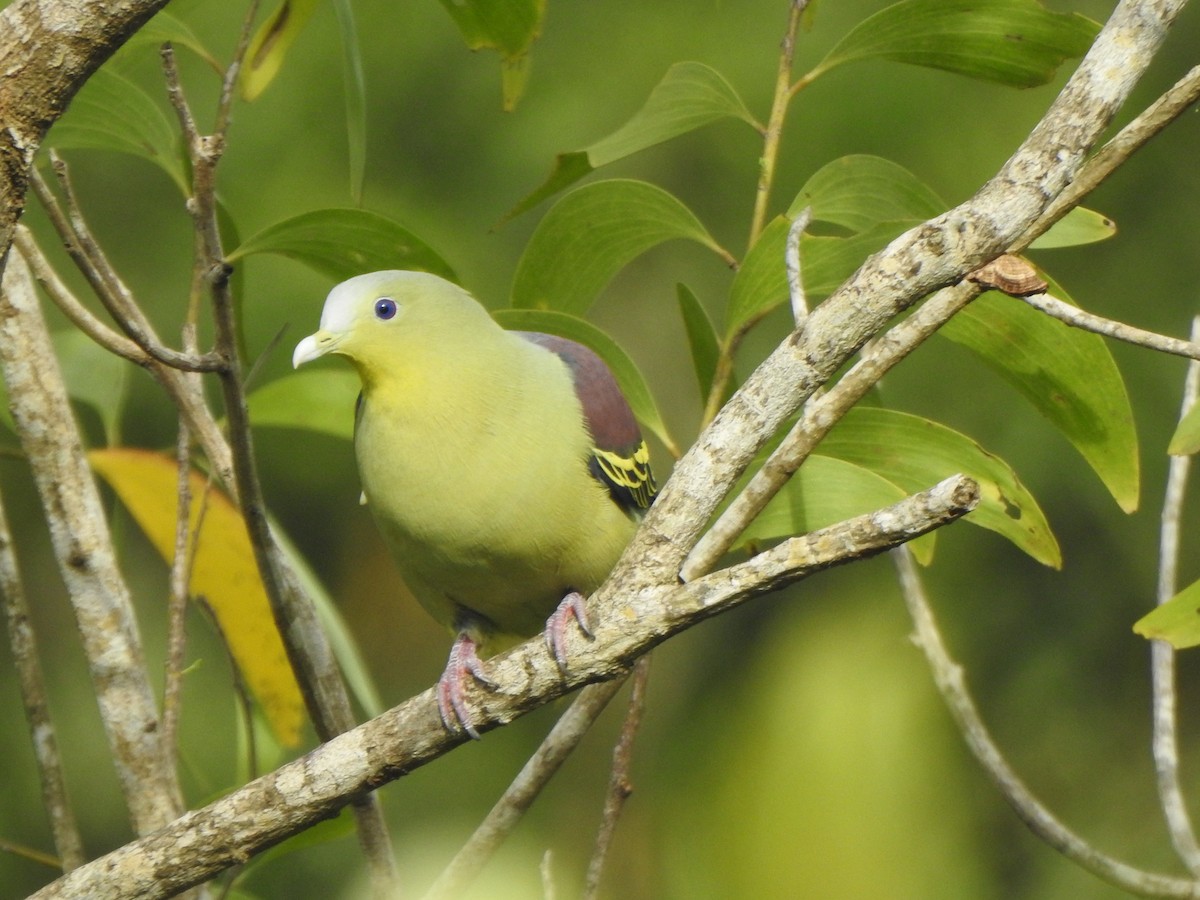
[227,209,457,281]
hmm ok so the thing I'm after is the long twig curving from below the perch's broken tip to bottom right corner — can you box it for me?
[892,547,1200,898]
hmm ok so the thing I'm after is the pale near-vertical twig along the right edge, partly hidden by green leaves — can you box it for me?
[1150,317,1200,877]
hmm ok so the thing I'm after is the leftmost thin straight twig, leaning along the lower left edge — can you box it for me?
[0,472,84,872]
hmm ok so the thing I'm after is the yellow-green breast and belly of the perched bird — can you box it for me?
[355,335,635,638]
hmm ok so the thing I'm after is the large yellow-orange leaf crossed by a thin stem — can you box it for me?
[88,448,305,746]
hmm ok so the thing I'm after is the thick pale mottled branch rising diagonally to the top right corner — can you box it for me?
[624,0,1186,593]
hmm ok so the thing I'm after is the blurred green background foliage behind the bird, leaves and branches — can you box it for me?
[0,0,1200,899]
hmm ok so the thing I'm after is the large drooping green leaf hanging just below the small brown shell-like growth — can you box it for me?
[941,272,1139,512]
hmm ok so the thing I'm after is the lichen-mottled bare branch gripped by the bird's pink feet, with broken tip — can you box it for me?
[34,475,979,900]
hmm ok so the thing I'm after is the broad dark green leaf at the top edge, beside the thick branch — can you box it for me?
[806,0,1099,88]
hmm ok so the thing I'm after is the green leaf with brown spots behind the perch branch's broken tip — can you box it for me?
[825,407,1062,569]
